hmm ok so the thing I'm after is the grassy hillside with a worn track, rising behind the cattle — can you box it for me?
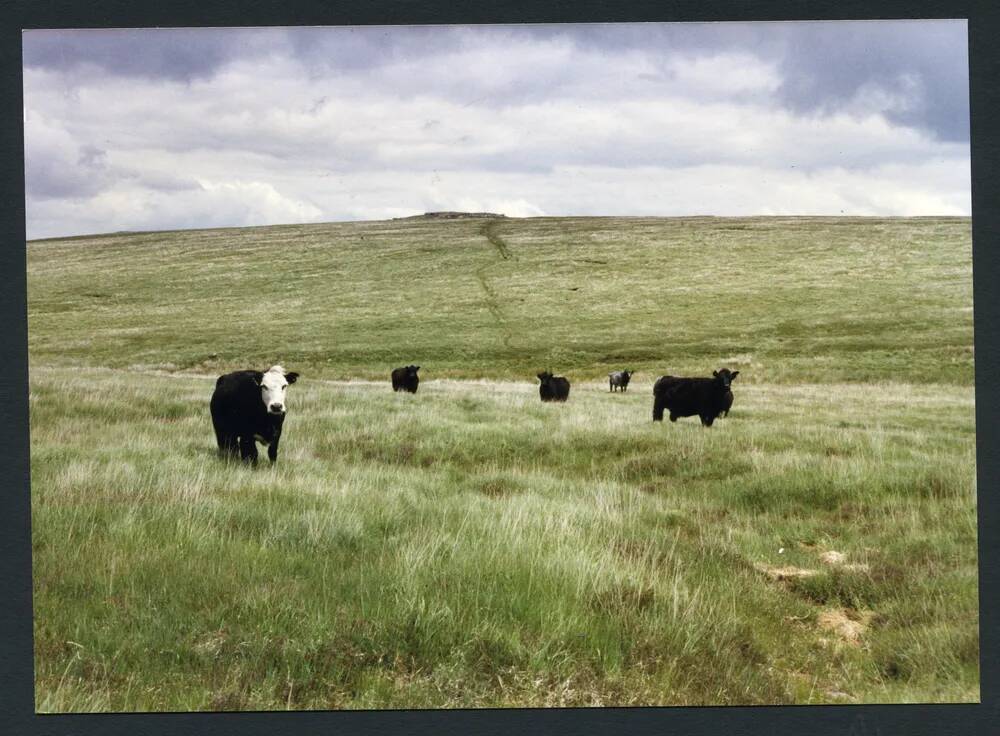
[28,218,972,385]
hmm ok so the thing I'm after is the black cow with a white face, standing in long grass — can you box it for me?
[210,365,299,465]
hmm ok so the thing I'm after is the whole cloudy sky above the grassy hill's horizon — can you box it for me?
[23,20,971,239]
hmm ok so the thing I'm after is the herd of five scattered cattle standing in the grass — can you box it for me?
[209,365,740,465]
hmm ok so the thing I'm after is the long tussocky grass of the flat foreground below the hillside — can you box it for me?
[32,368,978,710]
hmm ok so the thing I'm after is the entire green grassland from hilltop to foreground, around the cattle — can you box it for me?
[28,218,979,711]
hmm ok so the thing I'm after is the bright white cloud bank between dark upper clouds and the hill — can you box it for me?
[17,24,970,237]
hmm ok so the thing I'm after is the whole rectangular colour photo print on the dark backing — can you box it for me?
[23,20,980,713]
